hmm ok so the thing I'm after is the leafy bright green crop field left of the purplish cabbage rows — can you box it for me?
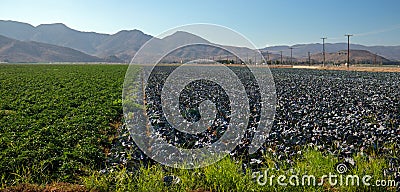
[0,65,132,184]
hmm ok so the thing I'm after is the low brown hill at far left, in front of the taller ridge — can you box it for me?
[0,35,104,63]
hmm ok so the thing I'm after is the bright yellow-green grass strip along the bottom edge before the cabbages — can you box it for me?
[83,149,395,192]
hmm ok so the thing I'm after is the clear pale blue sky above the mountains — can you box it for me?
[0,0,400,47]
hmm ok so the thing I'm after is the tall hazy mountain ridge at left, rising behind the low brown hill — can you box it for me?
[0,20,152,60]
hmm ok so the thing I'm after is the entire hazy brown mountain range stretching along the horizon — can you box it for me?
[0,20,400,62]
